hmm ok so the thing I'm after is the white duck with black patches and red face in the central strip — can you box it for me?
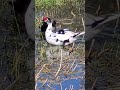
[43,17,85,45]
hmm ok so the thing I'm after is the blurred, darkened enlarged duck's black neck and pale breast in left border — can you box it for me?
[9,0,35,41]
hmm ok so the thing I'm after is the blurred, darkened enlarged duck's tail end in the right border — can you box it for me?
[85,13,120,41]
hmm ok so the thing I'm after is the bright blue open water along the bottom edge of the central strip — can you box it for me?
[36,79,85,90]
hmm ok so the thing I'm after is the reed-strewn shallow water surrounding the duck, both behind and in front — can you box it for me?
[35,3,85,90]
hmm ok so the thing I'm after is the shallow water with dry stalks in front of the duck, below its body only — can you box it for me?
[35,26,85,90]
